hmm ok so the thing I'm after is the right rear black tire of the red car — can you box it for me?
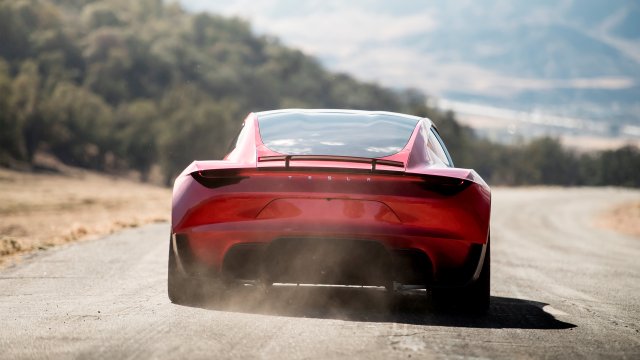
[431,242,491,314]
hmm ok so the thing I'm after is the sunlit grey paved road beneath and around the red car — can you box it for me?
[0,189,640,359]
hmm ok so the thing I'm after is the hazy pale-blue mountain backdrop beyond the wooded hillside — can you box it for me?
[181,0,640,124]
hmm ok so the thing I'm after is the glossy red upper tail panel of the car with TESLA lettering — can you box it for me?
[172,158,489,246]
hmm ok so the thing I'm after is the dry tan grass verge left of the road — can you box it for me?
[0,169,171,265]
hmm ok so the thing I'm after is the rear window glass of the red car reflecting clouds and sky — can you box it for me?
[258,112,419,158]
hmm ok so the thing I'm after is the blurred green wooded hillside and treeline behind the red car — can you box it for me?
[0,0,640,187]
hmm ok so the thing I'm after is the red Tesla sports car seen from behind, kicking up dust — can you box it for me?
[168,109,491,311]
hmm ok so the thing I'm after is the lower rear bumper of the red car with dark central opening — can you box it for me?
[172,219,486,287]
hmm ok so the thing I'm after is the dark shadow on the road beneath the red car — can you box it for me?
[179,285,576,329]
